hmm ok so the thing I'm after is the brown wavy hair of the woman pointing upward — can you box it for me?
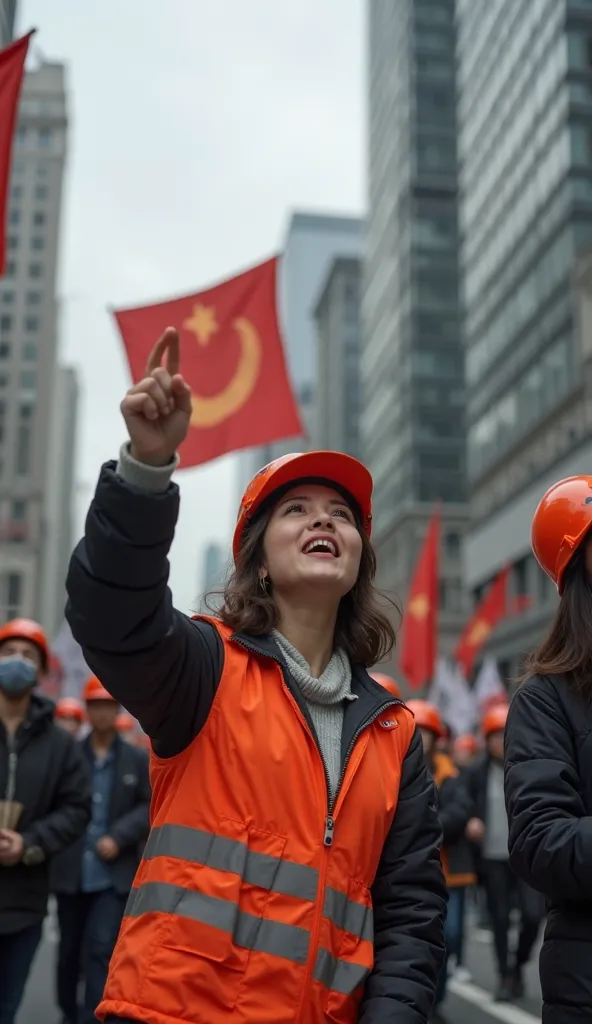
[208,506,400,668]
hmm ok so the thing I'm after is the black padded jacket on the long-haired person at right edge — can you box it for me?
[505,676,592,1024]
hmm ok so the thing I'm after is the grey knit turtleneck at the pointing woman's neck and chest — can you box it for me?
[273,630,357,799]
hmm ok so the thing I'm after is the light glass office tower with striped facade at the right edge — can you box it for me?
[457,0,592,675]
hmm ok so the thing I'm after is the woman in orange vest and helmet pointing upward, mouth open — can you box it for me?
[68,329,446,1024]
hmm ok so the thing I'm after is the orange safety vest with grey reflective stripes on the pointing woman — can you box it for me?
[96,620,414,1024]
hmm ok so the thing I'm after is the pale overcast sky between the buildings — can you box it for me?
[18,0,365,610]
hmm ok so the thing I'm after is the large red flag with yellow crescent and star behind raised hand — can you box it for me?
[115,258,302,469]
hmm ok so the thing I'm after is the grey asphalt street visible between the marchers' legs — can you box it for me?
[16,918,541,1024]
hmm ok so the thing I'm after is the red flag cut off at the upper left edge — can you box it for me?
[0,32,34,275]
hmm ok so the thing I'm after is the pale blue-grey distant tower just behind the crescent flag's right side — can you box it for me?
[238,212,362,496]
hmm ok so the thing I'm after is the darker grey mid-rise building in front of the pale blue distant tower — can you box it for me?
[313,256,362,459]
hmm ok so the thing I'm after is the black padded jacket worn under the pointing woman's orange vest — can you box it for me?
[67,463,446,1024]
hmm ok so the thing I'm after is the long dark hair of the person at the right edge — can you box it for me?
[522,545,592,697]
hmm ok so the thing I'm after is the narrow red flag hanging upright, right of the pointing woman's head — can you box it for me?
[399,506,440,690]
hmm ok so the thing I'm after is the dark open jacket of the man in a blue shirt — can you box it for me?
[50,736,151,896]
